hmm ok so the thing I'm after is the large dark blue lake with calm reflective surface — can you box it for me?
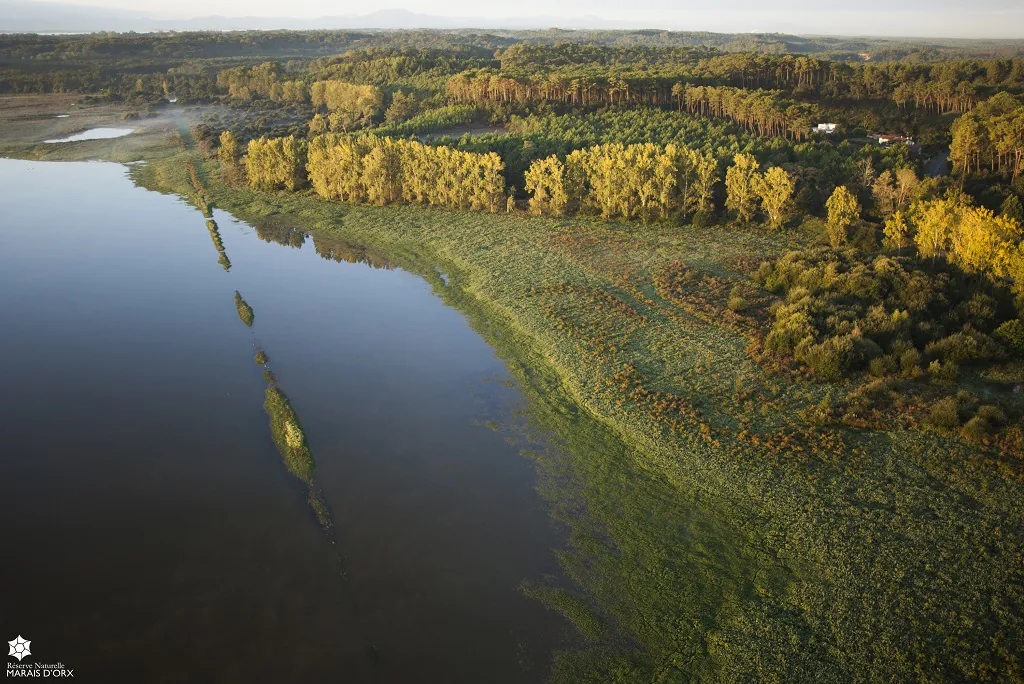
[0,160,565,682]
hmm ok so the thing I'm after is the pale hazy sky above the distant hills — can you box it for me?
[28,0,1024,38]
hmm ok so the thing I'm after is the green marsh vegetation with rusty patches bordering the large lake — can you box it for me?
[4,94,1024,682]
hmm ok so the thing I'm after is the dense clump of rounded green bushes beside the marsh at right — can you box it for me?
[755,249,1020,384]
